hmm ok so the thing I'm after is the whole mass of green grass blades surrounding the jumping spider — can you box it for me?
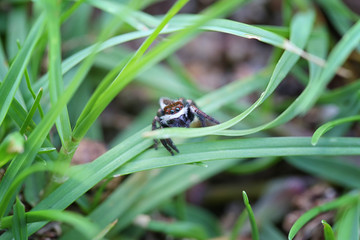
[0,0,360,240]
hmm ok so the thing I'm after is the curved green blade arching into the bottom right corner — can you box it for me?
[288,191,360,240]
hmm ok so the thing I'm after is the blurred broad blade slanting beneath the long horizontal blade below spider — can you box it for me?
[90,159,237,235]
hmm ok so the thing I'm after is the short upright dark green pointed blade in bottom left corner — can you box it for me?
[11,198,28,240]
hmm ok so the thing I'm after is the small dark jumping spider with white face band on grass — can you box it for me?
[152,97,219,155]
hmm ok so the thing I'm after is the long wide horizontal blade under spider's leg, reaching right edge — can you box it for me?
[113,137,360,175]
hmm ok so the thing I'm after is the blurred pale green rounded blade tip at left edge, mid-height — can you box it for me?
[0,132,25,167]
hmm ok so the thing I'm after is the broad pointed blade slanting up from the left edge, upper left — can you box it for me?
[0,15,45,126]
